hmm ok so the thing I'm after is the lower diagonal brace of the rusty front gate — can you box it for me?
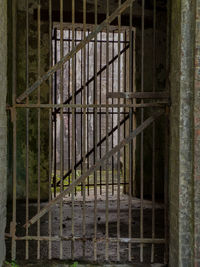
[24,111,164,227]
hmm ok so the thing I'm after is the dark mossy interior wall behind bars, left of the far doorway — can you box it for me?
[8,0,49,200]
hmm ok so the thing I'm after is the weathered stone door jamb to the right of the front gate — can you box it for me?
[169,0,195,267]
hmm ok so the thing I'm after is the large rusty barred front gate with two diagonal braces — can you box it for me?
[7,0,169,263]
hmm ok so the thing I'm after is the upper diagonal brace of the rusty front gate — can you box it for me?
[17,0,134,103]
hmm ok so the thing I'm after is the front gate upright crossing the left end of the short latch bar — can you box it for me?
[105,0,110,261]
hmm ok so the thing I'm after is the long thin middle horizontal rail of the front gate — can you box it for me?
[7,101,169,109]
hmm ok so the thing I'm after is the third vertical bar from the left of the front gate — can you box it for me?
[37,0,41,260]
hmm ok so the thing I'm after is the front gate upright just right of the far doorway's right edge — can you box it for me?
[140,0,145,262]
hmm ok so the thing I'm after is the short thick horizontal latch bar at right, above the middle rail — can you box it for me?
[107,91,169,99]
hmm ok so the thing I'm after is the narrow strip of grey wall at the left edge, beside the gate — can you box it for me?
[0,0,7,266]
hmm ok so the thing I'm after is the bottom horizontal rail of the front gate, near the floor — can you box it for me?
[7,235,166,244]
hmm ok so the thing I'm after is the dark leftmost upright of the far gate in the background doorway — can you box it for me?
[53,28,58,197]
